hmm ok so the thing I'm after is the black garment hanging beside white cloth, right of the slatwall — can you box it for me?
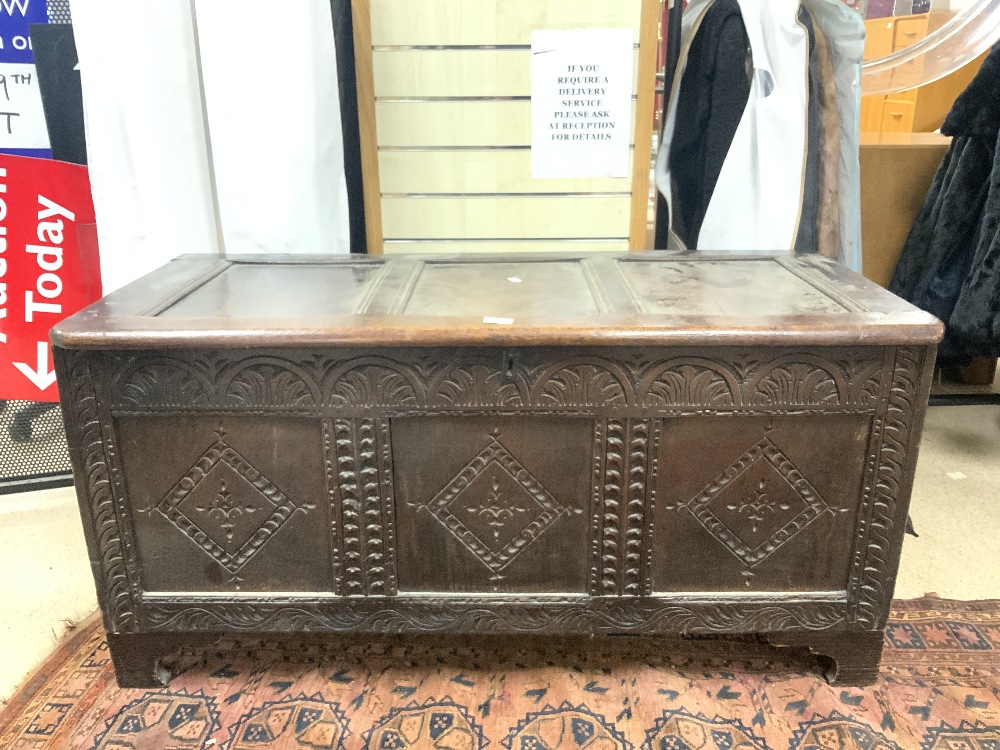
[670,0,750,248]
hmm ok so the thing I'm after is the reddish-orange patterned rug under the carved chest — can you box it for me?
[0,598,1000,750]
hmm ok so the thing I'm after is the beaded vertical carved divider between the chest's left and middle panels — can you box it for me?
[325,419,396,596]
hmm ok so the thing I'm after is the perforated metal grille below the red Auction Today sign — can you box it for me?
[0,401,73,495]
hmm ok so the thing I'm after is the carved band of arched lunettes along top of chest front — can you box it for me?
[112,349,881,414]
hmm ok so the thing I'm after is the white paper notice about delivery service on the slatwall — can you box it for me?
[531,29,634,179]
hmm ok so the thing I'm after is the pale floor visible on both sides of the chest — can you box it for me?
[0,406,1000,699]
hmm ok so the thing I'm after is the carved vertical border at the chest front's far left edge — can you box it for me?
[55,349,139,633]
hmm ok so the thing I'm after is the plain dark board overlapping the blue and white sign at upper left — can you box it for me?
[30,23,87,164]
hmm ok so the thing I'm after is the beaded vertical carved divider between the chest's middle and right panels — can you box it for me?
[590,419,659,596]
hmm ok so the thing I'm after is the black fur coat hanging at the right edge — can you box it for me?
[889,46,1000,360]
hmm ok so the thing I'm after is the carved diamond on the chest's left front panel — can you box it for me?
[157,433,298,576]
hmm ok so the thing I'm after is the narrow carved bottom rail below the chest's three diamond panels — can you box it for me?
[146,596,844,634]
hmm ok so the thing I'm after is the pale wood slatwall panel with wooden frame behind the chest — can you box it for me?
[354,0,658,253]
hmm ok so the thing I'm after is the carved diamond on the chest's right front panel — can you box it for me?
[687,437,830,567]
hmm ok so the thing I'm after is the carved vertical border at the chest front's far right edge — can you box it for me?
[851,347,933,629]
